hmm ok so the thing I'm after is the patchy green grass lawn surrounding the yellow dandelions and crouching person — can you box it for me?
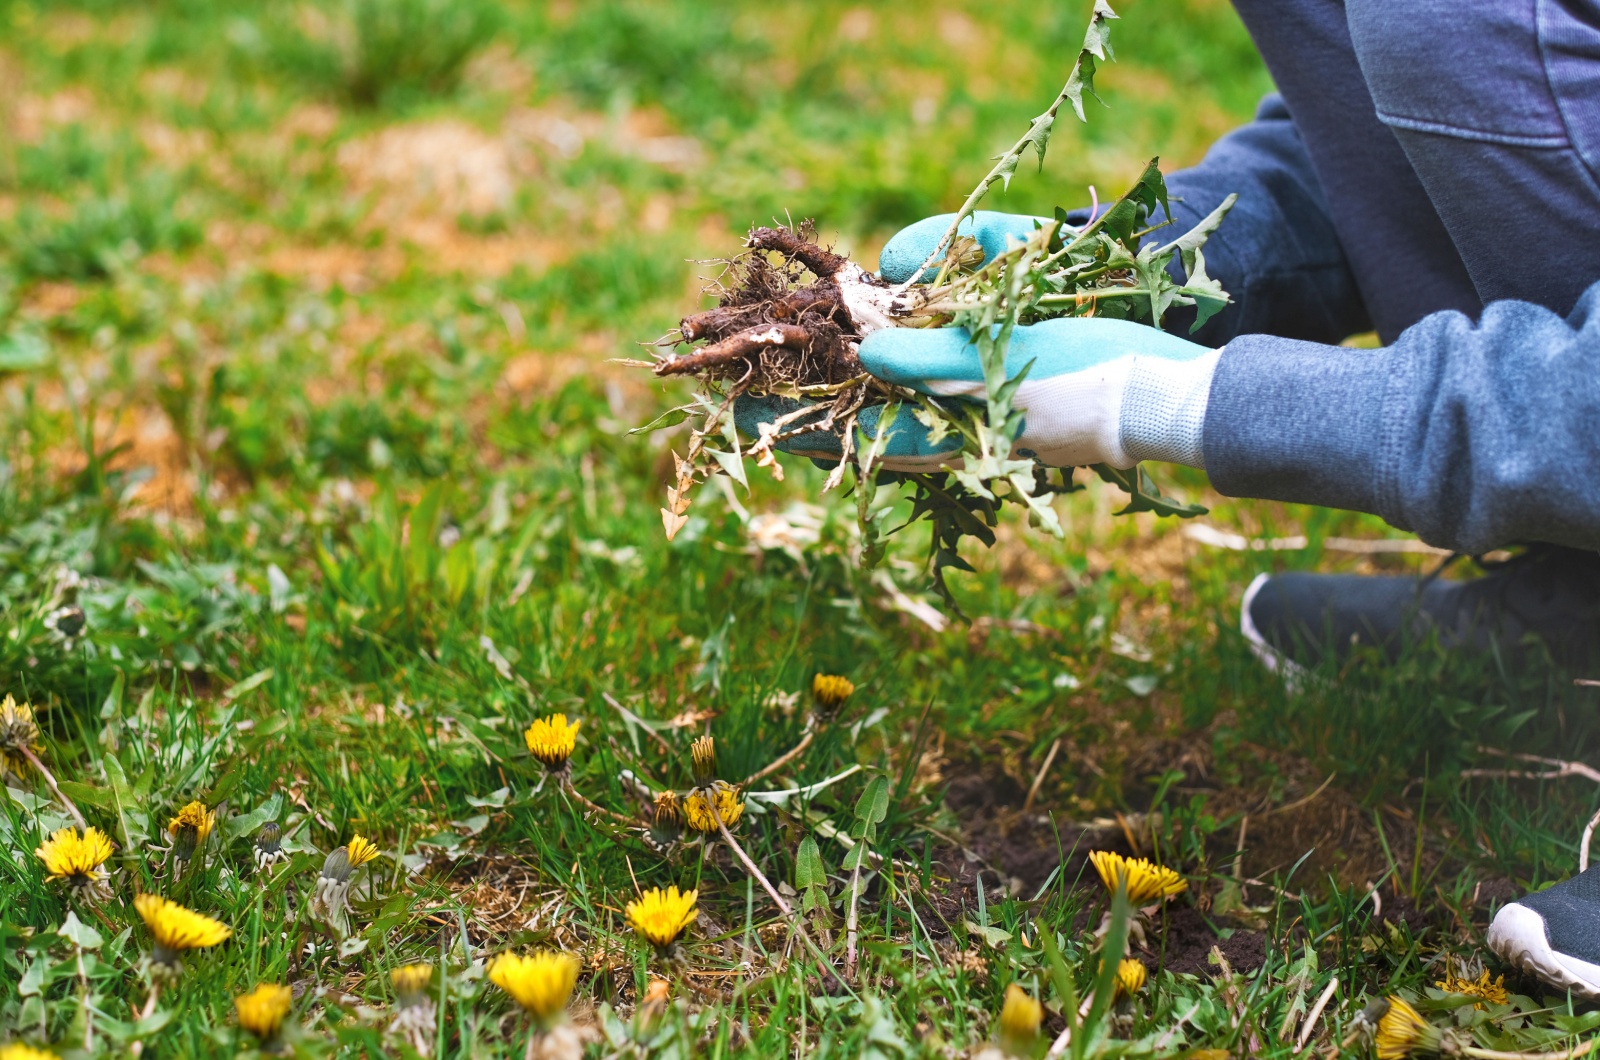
[0,0,1597,1057]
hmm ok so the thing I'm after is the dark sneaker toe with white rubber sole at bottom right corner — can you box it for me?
[1488,866,1600,998]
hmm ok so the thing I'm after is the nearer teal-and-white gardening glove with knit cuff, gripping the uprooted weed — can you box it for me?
[736,315,1219,471]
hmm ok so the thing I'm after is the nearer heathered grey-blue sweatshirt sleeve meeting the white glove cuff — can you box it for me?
[1202,283,1600,552]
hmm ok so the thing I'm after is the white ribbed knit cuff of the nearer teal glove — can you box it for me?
[1118,349,1222,468]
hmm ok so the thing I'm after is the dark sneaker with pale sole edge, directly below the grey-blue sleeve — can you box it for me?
[1240,544,1600,671]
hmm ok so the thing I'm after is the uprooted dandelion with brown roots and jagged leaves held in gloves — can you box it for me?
[635,0,1234,607]
